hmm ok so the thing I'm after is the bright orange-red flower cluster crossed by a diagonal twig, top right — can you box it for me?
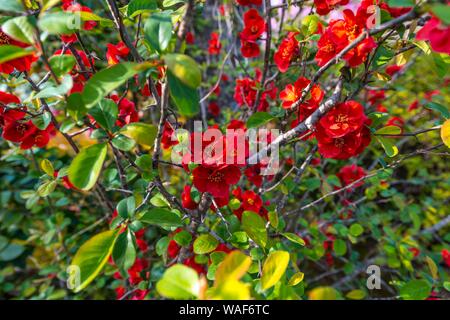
[316,1,377,67]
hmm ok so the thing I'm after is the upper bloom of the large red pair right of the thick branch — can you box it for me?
[320,101,366,138]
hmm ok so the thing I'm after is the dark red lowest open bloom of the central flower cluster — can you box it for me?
[192,165,241,198]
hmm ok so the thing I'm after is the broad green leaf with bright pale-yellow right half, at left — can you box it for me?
[69,143,107,191]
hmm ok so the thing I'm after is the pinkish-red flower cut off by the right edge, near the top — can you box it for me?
[416,16,450,55]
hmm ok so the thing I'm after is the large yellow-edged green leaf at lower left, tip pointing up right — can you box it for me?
[71,230,119,292]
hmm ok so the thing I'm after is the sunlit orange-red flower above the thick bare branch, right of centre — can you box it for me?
[280,77,324,110]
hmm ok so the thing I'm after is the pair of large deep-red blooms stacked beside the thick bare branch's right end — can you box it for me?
[316,101,371,159]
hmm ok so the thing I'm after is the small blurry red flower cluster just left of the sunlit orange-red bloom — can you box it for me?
[234,69,278,111]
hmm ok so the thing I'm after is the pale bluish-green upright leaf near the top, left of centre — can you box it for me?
[144,13,172,52]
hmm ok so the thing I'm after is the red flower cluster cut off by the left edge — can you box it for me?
[0,91,55,149]
